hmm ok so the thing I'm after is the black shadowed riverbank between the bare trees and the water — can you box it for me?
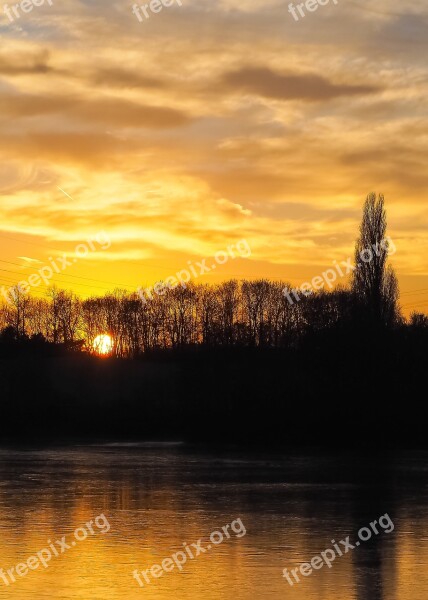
[0,328,427,447]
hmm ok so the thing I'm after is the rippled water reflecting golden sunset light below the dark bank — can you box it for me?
[0,445,428,600]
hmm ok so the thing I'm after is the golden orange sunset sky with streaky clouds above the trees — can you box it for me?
[0,0,428,312]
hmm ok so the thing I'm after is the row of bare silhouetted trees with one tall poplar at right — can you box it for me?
[0,194,428,357]
